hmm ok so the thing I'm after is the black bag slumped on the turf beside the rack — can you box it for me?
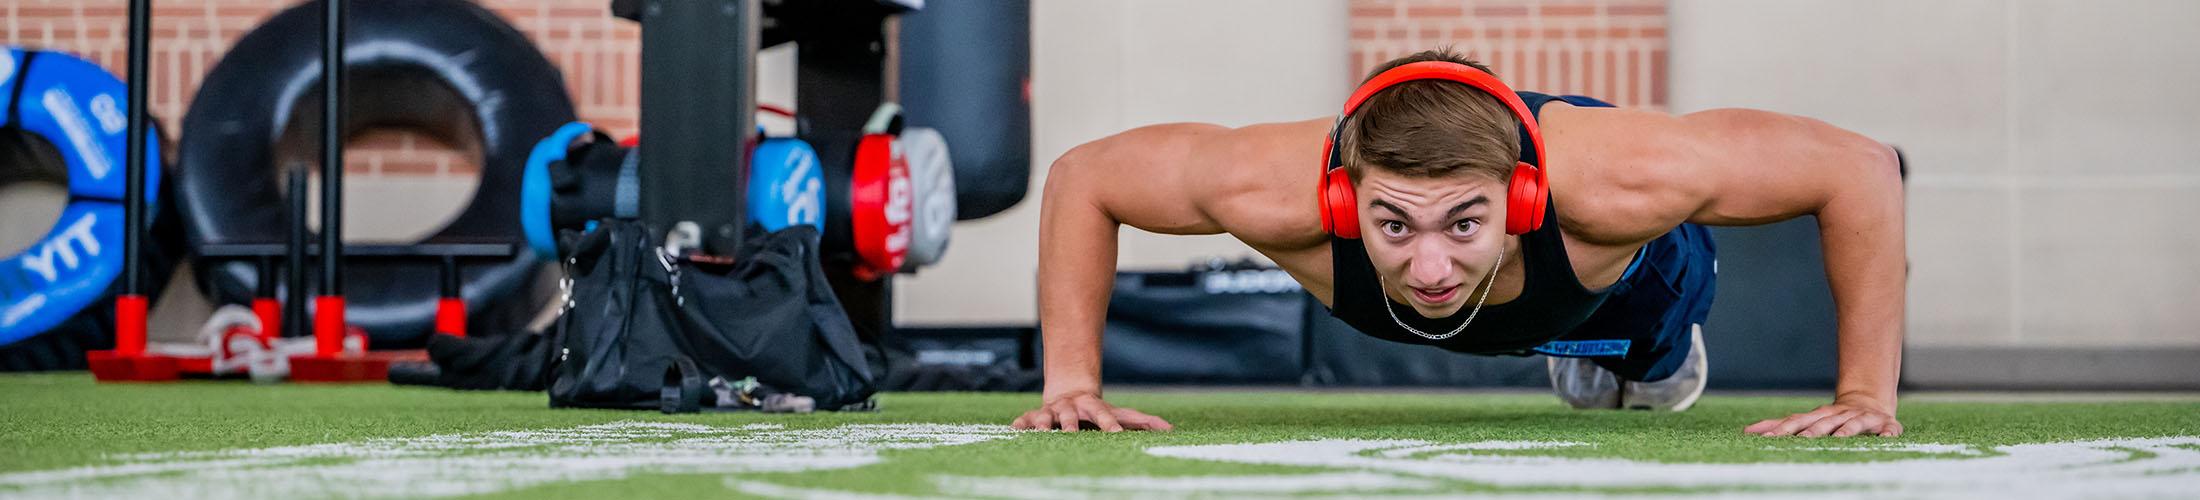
[550,218,878,412]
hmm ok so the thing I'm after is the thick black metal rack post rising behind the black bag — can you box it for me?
[640,0,759,256]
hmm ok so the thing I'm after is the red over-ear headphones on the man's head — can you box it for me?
[1320,62,1551,238]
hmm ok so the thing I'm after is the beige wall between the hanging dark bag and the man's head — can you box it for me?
[893,0,1351,326]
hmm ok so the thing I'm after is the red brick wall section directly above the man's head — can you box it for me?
[1351,0,1665,108]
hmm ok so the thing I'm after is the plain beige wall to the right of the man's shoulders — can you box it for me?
[1670,0,2200,348]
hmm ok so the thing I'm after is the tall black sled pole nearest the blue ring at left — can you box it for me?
[123,0,152,295]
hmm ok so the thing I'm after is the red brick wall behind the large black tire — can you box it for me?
[0,0,640,176]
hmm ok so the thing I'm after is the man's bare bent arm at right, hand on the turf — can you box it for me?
[1628,110,1907,436]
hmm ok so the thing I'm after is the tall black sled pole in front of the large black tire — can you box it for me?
[319,0,343,297]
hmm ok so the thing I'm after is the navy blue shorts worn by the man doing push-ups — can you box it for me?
[1536,225,1718,381]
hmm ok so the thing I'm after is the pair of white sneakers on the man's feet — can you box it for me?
[1547,324,1709,412]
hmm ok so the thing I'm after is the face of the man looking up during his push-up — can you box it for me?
[1355,167,1505,317]
